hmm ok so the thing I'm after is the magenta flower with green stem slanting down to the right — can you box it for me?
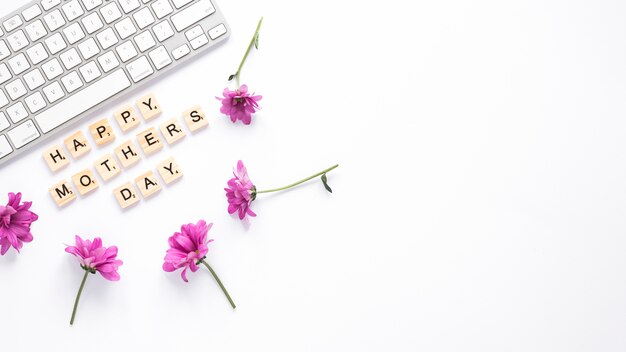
[163,220,235,309]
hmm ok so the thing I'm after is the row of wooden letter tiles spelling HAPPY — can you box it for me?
[43,93,163,172]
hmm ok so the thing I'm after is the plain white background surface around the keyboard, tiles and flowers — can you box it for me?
[0,0,626,351]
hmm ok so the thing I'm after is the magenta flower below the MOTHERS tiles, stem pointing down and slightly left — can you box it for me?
[65,236,123,325]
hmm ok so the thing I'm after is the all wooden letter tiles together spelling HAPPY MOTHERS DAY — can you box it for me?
[43,94,208,208]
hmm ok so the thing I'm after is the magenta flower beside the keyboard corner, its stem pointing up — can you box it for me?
[215,17,263,125]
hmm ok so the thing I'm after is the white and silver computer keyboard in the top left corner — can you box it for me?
[0,0,230,167]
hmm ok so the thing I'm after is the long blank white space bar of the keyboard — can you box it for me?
[35,69,130,133]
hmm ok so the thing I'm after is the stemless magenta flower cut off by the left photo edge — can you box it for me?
[0,192,39,255]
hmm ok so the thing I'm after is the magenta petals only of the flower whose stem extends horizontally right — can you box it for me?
[224,160,256,220]
